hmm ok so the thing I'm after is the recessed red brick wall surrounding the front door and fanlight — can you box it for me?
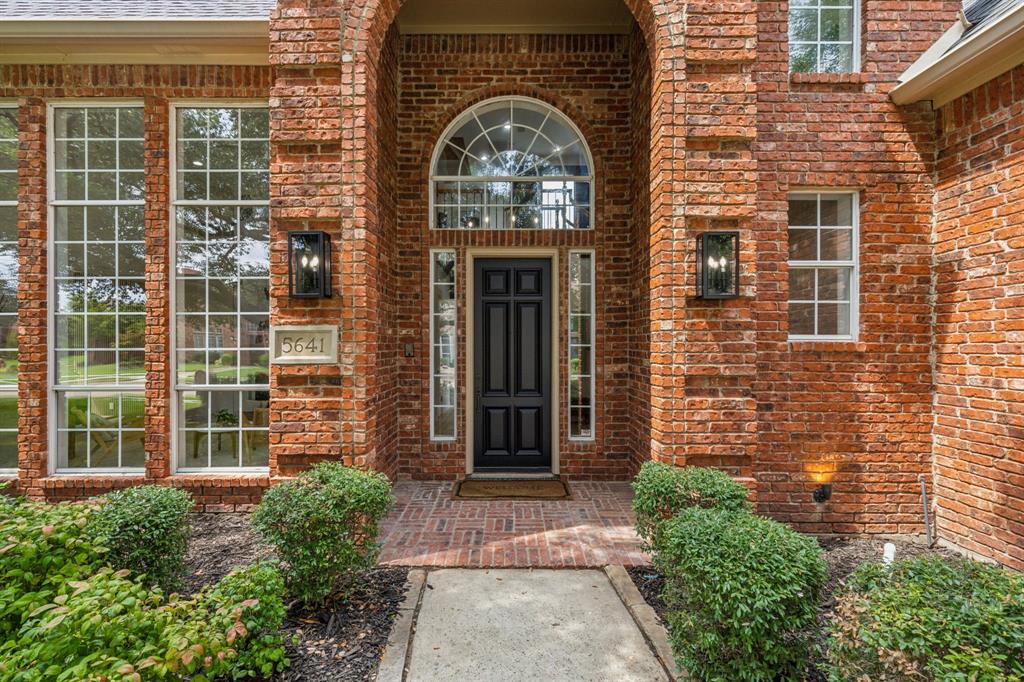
[397,35,633,478]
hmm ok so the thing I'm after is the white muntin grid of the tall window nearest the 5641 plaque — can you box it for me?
[172,102,269,472]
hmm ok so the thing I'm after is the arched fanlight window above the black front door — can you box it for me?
[430,97,594,229]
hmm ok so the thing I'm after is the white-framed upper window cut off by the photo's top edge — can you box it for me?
[790,0,860,74]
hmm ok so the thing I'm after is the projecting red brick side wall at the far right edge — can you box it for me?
[934,67,1024,569]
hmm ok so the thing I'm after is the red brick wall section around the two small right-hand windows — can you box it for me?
[753,0,959,534]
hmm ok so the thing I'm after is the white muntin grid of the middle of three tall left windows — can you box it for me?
[47,102,145,473]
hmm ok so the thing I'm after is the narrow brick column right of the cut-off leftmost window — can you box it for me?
[17,97,49,499]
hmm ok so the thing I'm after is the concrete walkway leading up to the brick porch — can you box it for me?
[377,569,670,682]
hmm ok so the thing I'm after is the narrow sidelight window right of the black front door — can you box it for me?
[568,251,595,440]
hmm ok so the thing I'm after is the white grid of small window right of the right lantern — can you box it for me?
[787,190,860,341]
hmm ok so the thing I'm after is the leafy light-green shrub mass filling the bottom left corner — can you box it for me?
[0,568,287,682]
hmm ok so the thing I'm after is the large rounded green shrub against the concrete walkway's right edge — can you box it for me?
[654,507,825,681]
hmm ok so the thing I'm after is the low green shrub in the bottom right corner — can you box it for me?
[827,557,1024,682]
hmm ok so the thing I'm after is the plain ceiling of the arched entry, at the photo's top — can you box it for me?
[397,0,633,34]
